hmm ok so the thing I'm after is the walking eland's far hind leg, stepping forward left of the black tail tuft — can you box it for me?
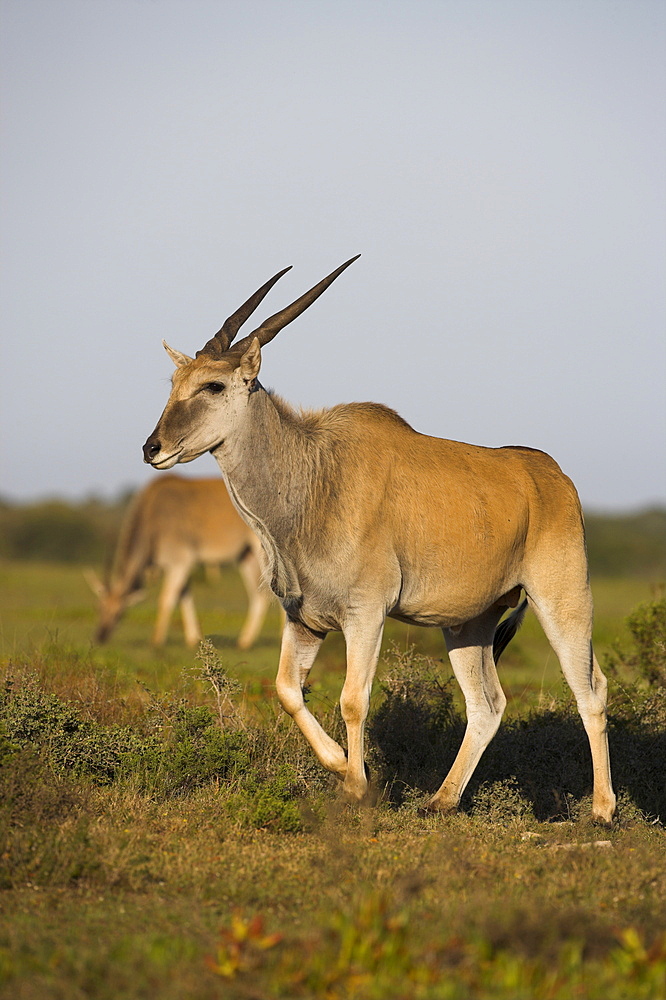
[426,608,506,812]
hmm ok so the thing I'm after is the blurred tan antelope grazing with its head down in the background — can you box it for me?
[87,476,270,649]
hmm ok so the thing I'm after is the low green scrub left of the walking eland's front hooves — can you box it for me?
[0,675,307,832]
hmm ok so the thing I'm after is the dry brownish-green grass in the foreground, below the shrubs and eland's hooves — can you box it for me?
[0,788,666,1000]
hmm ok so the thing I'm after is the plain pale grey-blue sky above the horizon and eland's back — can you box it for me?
[0,0,666,512]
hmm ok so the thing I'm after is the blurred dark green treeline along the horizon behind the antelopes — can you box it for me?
[0,493,666,581]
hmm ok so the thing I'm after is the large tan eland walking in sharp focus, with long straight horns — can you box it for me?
[143,258,615,823]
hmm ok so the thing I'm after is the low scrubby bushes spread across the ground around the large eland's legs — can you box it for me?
[0,599,666,831]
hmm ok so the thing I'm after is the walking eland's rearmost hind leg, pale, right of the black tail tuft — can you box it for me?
[528,582,616,824]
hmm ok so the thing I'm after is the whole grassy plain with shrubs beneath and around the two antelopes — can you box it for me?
[0,507,666,1000]
